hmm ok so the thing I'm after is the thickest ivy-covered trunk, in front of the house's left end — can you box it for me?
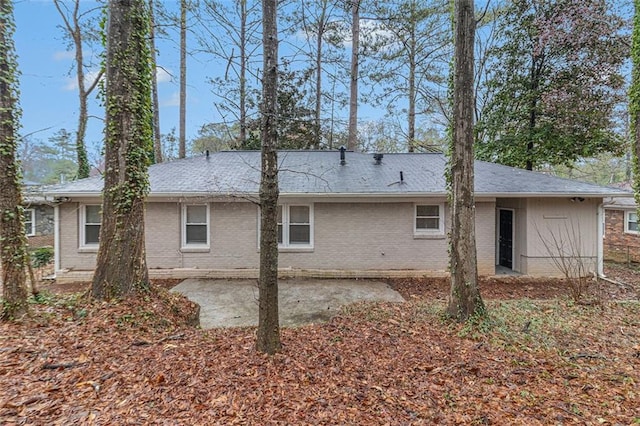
[91,0,153,299]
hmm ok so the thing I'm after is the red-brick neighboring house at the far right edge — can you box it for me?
[604,195,640,263]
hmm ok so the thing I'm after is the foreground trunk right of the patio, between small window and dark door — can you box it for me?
[447,0,485,321]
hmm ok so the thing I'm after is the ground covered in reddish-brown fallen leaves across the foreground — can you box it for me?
[0,268,640,425]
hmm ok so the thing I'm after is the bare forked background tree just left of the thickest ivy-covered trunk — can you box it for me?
[53,0,103,179]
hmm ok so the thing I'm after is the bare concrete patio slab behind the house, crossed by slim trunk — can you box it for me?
[171,278,404,328]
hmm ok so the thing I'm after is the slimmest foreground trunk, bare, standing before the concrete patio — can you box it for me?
[256,0,280,354]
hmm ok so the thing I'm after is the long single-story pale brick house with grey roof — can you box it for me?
[47,151,627,280]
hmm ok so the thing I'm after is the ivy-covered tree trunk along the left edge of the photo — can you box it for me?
[0,0,28,319]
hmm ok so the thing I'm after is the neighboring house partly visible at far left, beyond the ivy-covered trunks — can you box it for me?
[23,182,54,248]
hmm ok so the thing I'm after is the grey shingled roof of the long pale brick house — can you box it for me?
[47,151,629,198]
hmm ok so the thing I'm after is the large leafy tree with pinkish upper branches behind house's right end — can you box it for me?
[477,0,626,169]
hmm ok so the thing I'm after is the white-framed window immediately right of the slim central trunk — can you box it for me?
[278,204,313,248]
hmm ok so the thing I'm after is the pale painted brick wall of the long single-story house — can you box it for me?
[60,202,495,275]
